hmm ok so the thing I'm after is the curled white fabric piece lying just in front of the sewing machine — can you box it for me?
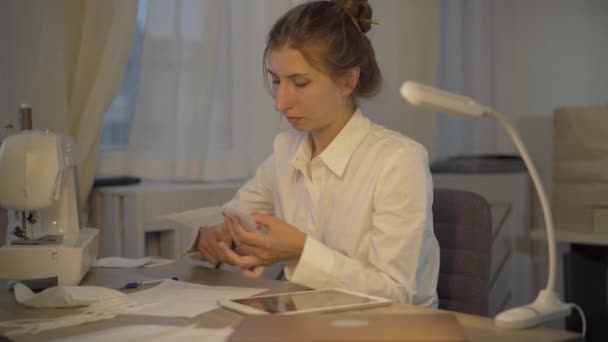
[14,283,127,308]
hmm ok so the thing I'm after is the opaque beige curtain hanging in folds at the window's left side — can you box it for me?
[65,0,137,199]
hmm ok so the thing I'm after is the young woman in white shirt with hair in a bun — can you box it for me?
[197,1,439,307]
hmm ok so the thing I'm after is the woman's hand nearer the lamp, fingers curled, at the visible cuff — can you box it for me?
[220,213,306,278]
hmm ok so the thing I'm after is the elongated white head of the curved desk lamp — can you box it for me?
[401,81,489,119]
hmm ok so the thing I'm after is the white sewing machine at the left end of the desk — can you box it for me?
[0,130,99,287]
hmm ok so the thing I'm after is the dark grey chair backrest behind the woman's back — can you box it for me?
[433,189,492,316]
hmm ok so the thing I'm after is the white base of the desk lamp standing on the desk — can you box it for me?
[494,289,574,329]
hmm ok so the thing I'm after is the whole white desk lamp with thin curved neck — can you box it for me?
[401,81,574,328]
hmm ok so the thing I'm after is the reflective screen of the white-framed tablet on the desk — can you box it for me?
[234,289,377,313]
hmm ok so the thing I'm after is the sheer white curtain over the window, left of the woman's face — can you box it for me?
[123,0,293,181]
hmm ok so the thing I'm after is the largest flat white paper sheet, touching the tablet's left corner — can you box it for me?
[129,279,266,318]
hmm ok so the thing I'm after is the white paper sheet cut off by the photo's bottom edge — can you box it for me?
[50,324,233,342]
